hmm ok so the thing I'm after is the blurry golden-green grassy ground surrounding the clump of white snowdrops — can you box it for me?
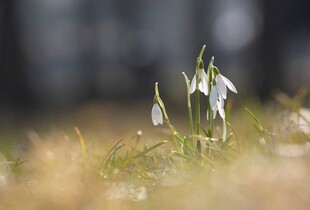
[0,94,310,210]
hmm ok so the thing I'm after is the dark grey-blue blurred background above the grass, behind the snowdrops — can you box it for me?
[0,0,310,112]
